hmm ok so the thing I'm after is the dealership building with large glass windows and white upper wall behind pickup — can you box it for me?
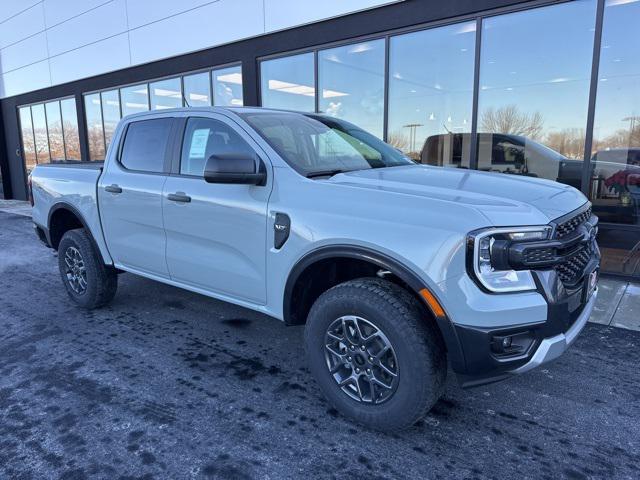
[0,0,640,278]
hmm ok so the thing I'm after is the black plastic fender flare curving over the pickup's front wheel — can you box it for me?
[283,245,465,372]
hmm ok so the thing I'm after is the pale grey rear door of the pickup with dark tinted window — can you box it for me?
[98,117,175,277]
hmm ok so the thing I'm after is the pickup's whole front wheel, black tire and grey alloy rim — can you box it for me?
[305,278,447,431]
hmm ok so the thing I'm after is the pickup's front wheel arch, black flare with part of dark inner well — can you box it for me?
[283,245,465,371]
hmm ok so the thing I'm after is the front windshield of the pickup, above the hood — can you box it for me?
[242,112,414,176]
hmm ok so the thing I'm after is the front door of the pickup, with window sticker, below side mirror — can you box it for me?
[162,115,272,304]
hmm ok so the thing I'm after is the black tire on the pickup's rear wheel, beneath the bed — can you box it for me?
[58,228,118,309]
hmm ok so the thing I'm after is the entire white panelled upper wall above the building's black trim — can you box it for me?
[0,0,401,98]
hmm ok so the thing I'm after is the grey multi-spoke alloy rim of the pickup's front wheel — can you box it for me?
[324,315,399,404]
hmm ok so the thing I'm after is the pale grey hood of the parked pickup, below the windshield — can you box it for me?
[328,165,587,226]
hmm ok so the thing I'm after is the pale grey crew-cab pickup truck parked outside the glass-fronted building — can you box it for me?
[30,108,600,430]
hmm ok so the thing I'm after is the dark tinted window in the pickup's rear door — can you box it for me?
[120,118,173,173]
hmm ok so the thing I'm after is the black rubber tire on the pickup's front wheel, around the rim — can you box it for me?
[305,278,447,432]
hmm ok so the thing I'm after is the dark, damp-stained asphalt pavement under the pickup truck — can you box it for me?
[0,212,640,480]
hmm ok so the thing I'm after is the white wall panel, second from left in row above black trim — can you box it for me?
[49,33,129,85]
